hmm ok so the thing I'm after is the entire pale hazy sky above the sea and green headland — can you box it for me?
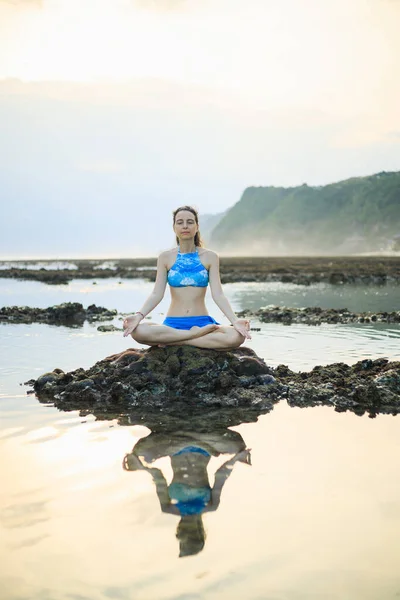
[0,0,400,257]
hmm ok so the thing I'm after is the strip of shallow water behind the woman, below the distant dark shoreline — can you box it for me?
[0,276,400,314]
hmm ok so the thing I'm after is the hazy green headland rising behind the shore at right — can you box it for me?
[211,171,400,254]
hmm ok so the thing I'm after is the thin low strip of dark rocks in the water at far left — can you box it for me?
[0,302,117,326]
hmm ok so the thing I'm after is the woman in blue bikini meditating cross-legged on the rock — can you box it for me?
[123,206,250,350]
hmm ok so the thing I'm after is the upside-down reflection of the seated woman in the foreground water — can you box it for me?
[123,429,251,556]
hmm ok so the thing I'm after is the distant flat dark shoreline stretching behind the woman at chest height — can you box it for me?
[0,256,400,285]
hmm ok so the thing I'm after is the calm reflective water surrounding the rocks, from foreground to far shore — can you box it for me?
[0,279,400,600]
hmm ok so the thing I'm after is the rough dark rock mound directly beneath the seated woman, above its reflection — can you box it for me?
[28,346,284,420]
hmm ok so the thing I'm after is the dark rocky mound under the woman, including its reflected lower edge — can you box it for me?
[27,346,286,431]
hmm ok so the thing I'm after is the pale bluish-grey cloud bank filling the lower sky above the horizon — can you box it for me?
[0,79,400,257]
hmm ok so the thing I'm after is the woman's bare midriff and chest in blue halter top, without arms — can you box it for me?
[166,248,210,317]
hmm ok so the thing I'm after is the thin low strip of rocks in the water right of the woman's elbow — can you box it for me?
[238,306,400,325]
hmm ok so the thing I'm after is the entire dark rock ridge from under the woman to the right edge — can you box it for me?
[29,346,400,420]
